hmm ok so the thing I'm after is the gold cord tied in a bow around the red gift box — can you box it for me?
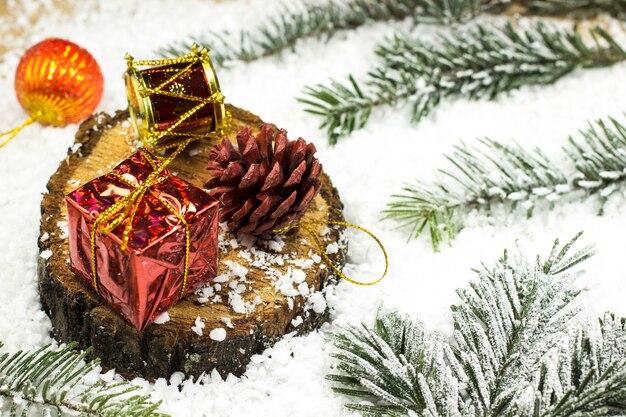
[91,139,192,296]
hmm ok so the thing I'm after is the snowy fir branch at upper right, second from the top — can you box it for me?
[300,23,626,143]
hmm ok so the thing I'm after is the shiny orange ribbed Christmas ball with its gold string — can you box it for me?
[0,38,104,148]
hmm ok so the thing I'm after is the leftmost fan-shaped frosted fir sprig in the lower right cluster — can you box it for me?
[327,312,463,415]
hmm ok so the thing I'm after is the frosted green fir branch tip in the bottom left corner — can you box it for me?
[0,344,167,417]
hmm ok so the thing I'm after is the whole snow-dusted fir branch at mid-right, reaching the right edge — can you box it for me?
[384,115,626,250]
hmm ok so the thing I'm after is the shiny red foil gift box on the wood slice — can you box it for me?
[65,149,219,330]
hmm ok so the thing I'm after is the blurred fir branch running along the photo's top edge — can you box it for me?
[157,0,626,66]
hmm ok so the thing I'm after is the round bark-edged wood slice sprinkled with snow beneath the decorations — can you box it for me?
[38,106,346,380]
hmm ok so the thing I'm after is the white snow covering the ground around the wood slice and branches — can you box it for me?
[0,0,626,417]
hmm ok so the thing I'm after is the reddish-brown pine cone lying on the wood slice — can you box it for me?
[206,124,322,234]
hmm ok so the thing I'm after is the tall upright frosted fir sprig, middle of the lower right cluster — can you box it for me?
[452,234,595,415]
